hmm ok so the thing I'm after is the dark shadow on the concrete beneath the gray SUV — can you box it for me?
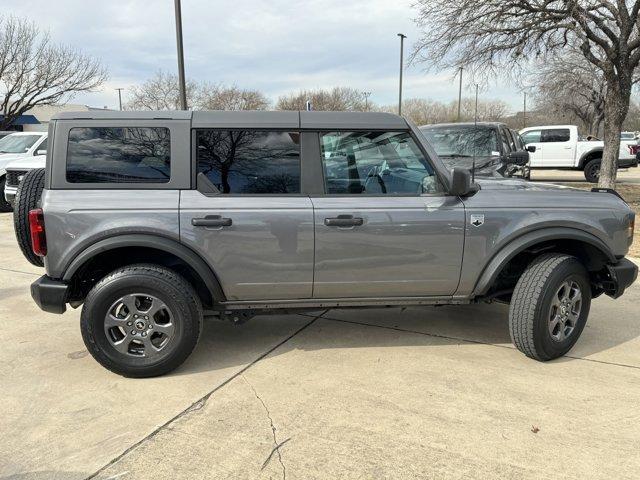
[172,300,640,375]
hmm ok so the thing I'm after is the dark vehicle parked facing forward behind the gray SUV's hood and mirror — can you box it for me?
[420,122,530,178]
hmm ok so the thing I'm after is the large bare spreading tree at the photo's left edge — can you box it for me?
[0,17,107,130]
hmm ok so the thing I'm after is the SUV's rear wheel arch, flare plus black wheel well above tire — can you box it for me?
[62,234,226,305]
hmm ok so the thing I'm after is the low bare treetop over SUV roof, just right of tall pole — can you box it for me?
[196,84,270,110]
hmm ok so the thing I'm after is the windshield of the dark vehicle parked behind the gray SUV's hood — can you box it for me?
[422,125,500,157]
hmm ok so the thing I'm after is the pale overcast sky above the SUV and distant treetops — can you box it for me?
[8,0,521,110]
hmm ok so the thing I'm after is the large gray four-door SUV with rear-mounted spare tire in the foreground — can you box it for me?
[16,112,637,377]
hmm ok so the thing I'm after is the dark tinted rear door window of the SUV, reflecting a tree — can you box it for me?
[196,130,300,193]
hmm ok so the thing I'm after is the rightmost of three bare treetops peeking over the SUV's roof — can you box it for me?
[276,87,374,112]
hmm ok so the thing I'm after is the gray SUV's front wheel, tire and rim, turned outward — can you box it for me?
[509,254,591,361]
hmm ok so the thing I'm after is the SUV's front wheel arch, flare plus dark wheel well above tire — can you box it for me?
[472,227,617,297]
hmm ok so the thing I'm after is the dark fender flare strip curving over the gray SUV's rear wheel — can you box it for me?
[62,234,226,303]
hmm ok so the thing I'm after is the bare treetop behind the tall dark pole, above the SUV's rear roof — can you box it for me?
[125,70,198,110]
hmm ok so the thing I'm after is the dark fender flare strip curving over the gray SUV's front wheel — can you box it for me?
[472,227,618,296]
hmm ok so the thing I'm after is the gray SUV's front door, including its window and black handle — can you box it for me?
[311,131,465,298]
